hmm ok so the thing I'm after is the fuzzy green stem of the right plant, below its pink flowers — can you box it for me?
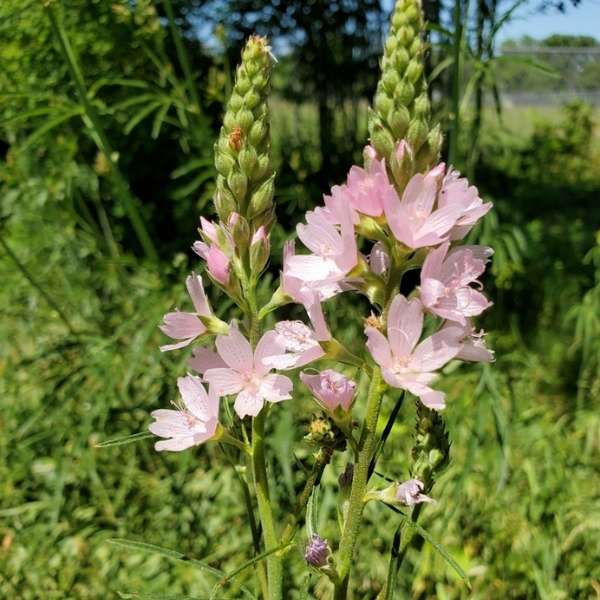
[334,368,384,600]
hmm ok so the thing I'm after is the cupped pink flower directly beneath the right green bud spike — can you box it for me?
[384,163,462,248]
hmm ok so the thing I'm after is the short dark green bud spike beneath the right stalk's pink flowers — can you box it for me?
[411,404,450,493]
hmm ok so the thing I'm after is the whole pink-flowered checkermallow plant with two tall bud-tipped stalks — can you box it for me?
[150,0,494,600]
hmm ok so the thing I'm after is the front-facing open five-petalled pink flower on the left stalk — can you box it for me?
[204,326,293,418]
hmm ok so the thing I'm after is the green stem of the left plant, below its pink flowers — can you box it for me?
[252,407,283,600]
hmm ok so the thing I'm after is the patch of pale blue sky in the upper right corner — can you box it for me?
[498,0,600,42]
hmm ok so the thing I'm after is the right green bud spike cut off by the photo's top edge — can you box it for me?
[369,0,442,178]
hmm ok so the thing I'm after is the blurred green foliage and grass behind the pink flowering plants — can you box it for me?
[0,0,600,600]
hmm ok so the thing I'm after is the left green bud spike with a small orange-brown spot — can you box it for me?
[215,36,274,229]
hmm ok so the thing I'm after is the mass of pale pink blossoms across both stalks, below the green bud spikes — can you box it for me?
[150,137,493,450]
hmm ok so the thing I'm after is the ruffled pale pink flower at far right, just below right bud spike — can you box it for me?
[438,170,492,240]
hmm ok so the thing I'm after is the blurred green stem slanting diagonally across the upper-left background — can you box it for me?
[46,3,158,262]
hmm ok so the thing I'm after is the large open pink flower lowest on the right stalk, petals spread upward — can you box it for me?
[365,294,461,410]
